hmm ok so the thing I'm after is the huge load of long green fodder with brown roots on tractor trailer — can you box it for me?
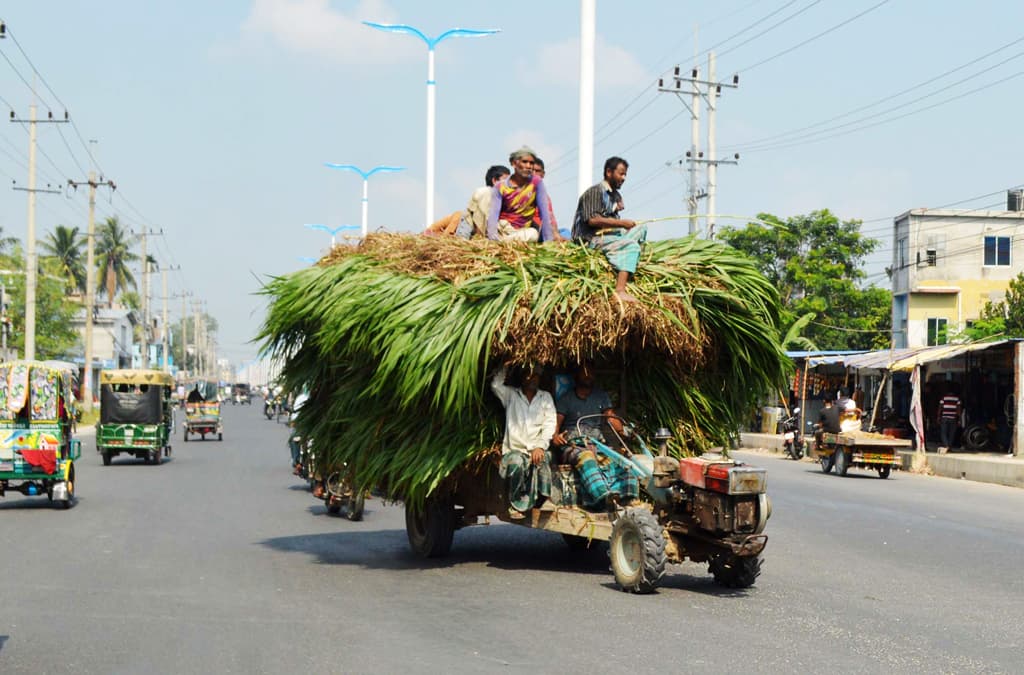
[259,235,787,501]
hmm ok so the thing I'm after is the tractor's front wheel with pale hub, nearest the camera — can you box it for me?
[608,507,667,593]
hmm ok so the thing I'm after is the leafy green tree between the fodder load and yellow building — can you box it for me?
[721,209,891,349]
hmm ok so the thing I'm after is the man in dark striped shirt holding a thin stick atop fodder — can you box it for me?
[572,157,647,302]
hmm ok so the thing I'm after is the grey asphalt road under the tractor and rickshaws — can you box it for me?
[0,404,1024,673]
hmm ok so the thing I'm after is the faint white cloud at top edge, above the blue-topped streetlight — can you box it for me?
[241,0,425,65]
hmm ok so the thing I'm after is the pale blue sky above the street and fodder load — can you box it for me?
[0,0,1024,362]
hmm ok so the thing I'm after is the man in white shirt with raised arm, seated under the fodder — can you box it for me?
[490,368,556,519]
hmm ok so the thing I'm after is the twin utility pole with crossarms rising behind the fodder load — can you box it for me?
[657,52,739,239]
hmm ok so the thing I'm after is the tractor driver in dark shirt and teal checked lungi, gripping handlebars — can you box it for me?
[552,364,640,507]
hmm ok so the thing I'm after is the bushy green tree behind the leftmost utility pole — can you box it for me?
[0,247,82,360]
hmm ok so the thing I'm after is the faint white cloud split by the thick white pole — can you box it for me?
[520,36,654,89]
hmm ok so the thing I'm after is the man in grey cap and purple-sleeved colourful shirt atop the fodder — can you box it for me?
[487,145,554,242]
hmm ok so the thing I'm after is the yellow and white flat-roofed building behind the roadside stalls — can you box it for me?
[892,191,1024,348]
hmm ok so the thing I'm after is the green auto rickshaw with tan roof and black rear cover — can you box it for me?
[96,370,174,466]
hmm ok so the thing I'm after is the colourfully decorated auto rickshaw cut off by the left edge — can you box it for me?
[0,361,82,508]
